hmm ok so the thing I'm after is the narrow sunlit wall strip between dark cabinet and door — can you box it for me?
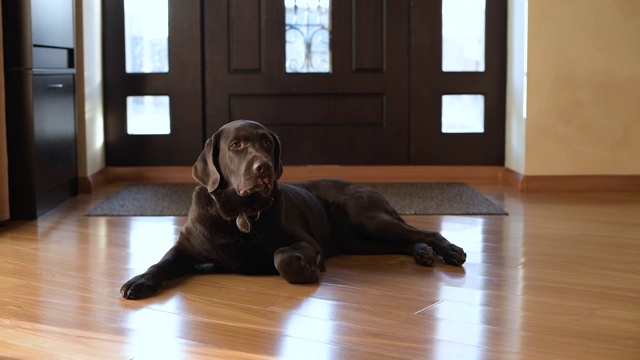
[76,0,105,177]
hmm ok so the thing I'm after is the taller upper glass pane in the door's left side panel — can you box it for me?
[124,0,169,73]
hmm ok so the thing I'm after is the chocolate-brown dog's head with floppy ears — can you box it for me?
[192,120,282,197]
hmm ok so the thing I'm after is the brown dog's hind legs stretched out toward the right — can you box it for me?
[345,212,467,266]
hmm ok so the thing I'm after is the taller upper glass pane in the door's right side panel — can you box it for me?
[442,0,486,71]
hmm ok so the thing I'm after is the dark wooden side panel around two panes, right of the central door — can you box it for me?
[411,0,507,165]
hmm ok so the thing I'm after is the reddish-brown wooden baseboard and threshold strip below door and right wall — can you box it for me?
[78,165,640,193]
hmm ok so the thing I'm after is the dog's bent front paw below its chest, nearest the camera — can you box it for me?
[273,242,324,284]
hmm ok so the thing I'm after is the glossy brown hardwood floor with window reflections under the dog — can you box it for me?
[0,178,640,359]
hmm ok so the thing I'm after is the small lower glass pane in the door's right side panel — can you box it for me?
[442,95,484,133]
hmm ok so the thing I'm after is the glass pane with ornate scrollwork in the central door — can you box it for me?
[284,0,331,73]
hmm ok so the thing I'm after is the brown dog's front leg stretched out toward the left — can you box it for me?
[120,246,196,300]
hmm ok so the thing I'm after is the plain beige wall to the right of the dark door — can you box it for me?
[524,0,640,175]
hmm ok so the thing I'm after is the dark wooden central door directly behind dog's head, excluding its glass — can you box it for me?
[203,0,409,164]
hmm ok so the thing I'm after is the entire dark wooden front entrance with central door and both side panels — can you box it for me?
[104,0,507,166]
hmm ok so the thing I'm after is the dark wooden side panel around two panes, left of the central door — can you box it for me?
[103,0,203,166]
